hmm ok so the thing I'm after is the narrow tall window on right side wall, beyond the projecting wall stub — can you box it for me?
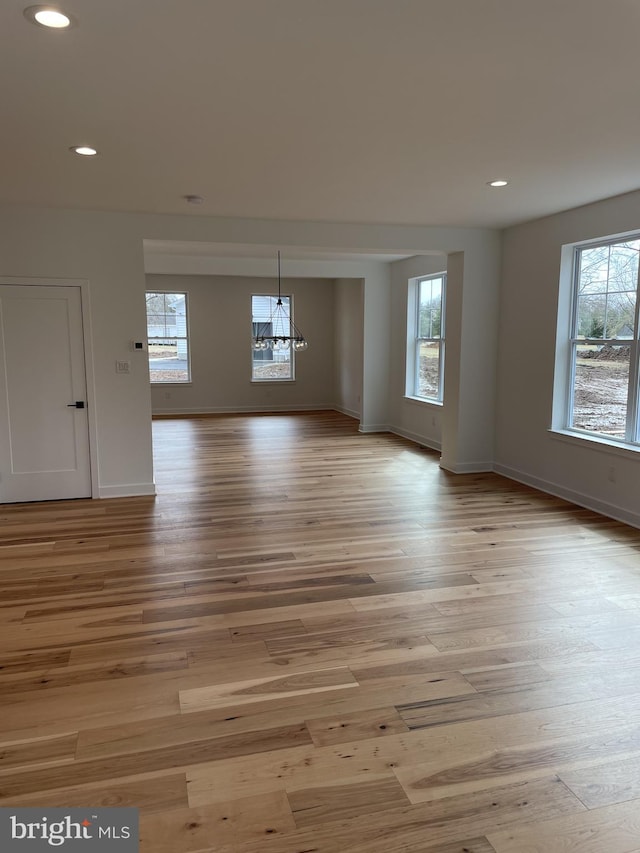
[406,273,447,403]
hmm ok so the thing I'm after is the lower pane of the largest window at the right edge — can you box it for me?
[571,344,630,439]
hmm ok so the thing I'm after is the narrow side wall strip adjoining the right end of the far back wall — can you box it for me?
[334,278,364,420]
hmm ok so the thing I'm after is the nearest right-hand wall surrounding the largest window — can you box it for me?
[495,193,640,526]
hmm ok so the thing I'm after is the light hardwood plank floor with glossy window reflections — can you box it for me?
[0,413,640,853]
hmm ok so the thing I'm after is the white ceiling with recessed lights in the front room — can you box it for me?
[5,0,640,227]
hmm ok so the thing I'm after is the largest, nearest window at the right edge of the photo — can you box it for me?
[567,235,640,444]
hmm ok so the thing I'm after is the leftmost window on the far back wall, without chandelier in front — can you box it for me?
[146,292,191,383]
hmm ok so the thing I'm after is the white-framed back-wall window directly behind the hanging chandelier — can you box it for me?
[251,294,294,382]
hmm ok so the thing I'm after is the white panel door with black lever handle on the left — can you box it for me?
[0,285,91,503]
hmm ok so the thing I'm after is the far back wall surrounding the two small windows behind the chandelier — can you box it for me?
[147,275,335,413]
